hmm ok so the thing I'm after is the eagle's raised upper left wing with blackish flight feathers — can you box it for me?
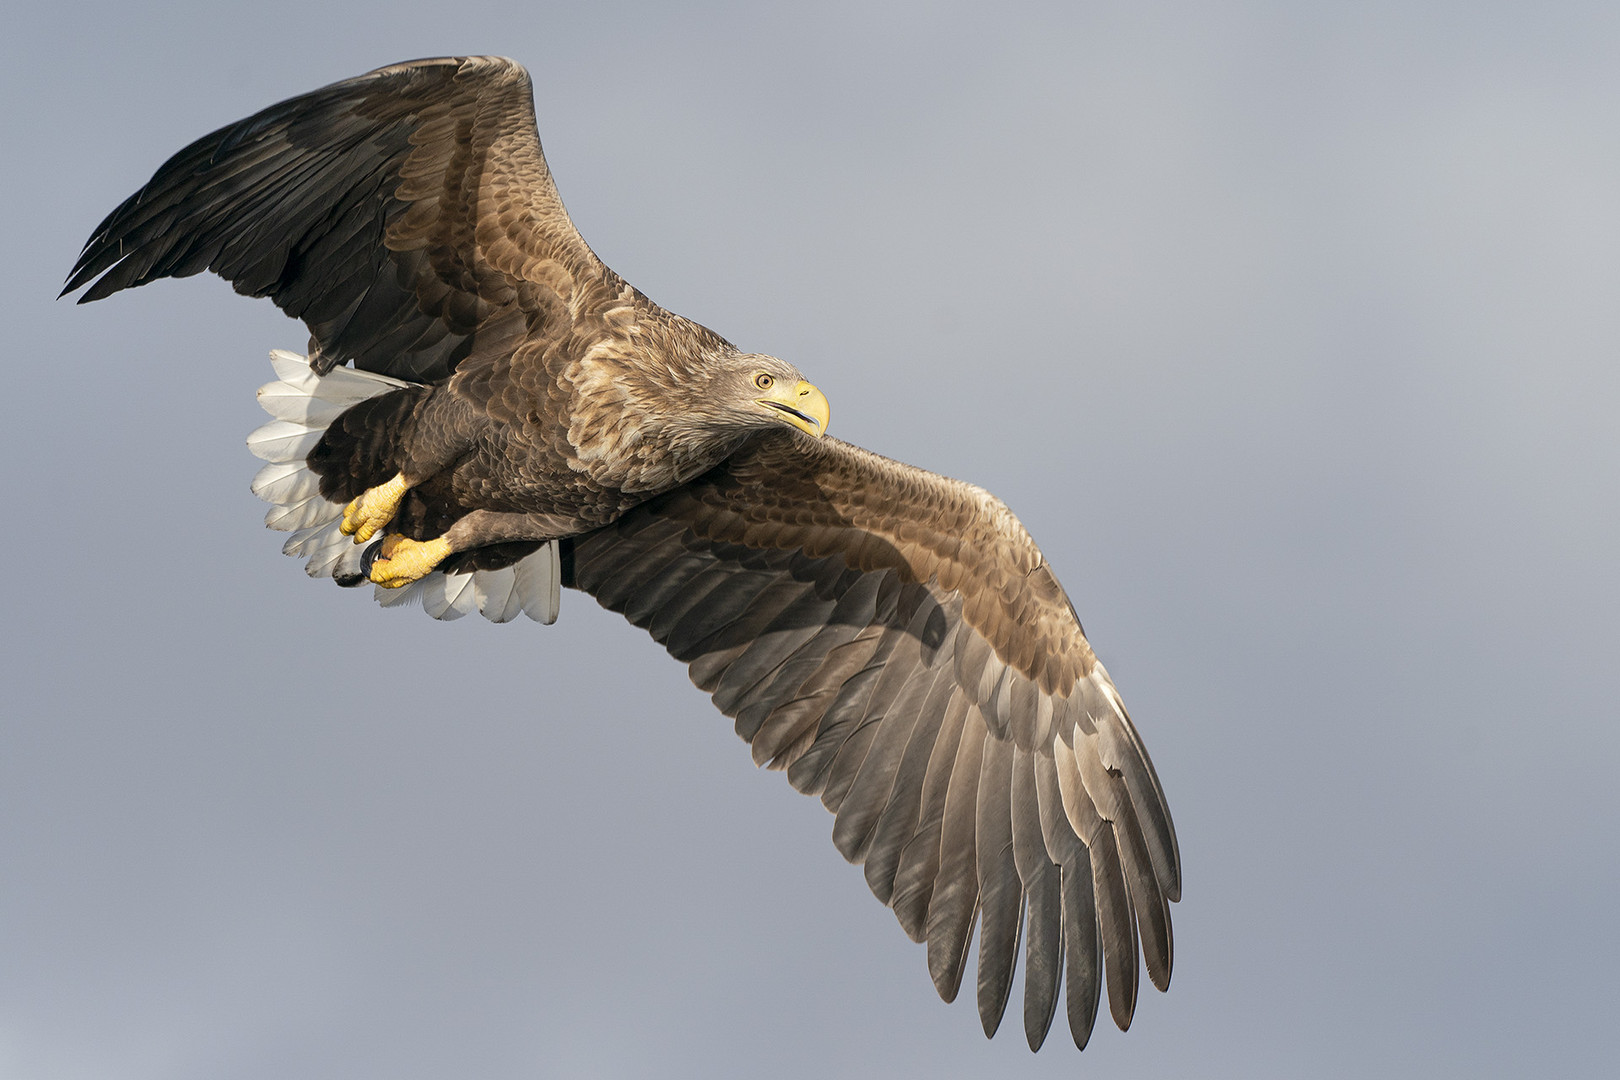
[63,57,624,382]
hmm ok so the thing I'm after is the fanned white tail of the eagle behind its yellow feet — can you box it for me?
[248,348,562,625]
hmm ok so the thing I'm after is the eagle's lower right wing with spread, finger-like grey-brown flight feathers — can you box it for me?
[565,432,1181,1048]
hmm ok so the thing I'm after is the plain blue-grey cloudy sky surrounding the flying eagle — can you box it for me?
[0,0,1620,1080]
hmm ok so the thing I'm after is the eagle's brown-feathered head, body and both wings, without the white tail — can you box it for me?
[65,58,1181,1048]
